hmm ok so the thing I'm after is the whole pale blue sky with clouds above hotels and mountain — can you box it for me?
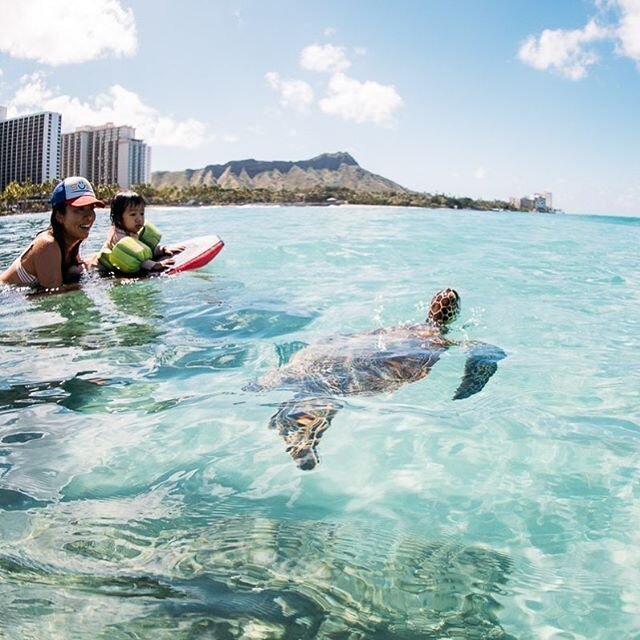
[0,0,640,214]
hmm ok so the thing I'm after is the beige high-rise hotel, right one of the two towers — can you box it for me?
[61,123,151,189]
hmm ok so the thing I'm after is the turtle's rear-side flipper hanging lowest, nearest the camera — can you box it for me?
[269,398,342,471]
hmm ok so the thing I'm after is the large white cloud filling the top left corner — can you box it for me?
[0,0,137,65]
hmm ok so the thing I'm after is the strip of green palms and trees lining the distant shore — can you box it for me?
[0,181,518,214]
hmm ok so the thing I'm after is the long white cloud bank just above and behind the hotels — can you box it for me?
[8,73,211,149]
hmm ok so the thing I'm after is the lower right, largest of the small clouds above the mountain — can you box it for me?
[320,73,403,124]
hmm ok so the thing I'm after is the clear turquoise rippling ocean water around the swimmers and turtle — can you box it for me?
[0,207,640,640]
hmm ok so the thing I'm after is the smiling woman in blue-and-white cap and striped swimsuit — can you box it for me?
[0,176,104,289]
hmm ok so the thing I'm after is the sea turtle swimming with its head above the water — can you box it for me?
[250,288,506,470]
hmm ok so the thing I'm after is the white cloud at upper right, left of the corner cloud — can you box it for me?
[518,20,610,80]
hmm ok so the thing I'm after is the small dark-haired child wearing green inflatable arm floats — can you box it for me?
[98,191,184,273]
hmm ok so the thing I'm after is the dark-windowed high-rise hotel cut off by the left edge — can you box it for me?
[0,107,62,192]
